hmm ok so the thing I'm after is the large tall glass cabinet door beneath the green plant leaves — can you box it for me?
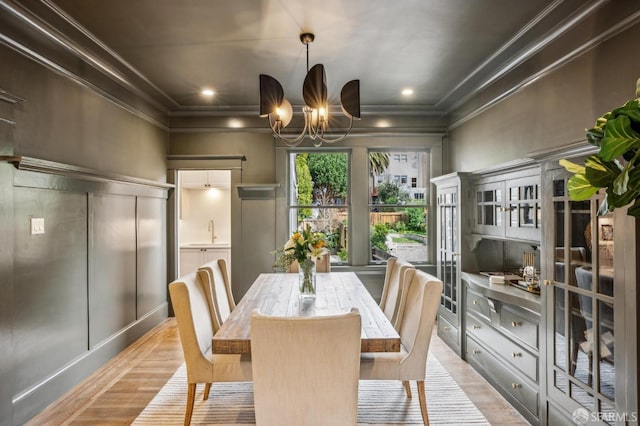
[545,172,617,424]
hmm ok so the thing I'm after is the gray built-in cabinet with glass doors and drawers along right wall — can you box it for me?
[433,154,640,426]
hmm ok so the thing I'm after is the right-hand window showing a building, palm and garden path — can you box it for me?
[369,150,430,263]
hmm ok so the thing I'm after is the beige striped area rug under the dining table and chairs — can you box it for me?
[133,354,489,426]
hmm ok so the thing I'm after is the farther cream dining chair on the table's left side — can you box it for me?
[198,259,236,333]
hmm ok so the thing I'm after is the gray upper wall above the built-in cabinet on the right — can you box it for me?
[449,5,640,171]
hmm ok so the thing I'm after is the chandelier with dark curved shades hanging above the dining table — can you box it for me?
[260,33,360,147]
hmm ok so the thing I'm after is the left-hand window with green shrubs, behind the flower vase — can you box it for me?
[289,151,349,263]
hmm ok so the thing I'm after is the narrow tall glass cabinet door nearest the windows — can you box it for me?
[438,187,458,323]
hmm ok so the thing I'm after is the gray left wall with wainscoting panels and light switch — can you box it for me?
[0,46,168,426]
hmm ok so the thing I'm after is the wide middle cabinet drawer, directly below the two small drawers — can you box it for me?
[465,314,538,382]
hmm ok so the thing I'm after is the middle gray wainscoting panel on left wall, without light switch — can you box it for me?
[89,194,136,348]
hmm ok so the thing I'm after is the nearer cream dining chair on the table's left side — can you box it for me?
[169,272,252,425]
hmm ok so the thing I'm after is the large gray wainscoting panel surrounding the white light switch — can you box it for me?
[13,187,89,399]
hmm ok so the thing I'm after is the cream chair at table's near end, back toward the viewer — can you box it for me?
[251,308,361,426]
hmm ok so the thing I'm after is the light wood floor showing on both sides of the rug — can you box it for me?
[27,318,529,426]
